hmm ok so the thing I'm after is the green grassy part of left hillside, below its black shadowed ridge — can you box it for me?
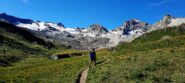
[0,23,48,66]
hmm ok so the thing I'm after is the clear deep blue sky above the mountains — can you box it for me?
[0,0,185,29]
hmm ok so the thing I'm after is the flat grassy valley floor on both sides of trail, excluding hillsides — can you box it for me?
[0,47,185,83]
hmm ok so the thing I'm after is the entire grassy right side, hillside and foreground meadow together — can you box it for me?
[88,26,185,83]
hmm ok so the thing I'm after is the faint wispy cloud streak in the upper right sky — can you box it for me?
[146,0,168,9]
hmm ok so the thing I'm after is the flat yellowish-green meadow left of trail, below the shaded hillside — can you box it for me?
[0,50,110,83]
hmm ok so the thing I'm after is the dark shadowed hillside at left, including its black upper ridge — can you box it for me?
[0,22,54,66]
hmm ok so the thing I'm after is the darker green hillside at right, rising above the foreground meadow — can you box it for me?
[114,27,185,55]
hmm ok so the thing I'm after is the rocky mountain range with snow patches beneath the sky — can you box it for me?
[0,13,185,49]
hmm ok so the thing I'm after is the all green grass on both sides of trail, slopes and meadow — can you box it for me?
[0,23,185,83]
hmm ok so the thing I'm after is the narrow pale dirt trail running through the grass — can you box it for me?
[76,57,109,83]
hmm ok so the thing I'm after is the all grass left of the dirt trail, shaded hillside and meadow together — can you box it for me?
[0,21,107,83]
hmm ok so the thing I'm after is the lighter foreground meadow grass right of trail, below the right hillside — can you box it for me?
[88,48,185,83]
